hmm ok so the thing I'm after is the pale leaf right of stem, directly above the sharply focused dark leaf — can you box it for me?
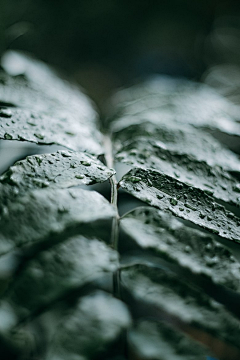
[115,139,240,206]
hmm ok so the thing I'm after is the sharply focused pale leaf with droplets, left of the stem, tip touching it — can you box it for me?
[0,150,115,197]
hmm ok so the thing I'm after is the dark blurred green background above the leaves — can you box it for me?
[0,0,240,106]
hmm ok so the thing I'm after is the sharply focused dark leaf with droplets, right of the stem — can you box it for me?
[120,169,240,243]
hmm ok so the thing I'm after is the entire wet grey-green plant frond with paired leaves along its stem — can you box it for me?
[0,53,240,360]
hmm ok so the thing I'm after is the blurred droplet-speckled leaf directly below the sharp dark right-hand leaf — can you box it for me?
[120,207,240,291]
